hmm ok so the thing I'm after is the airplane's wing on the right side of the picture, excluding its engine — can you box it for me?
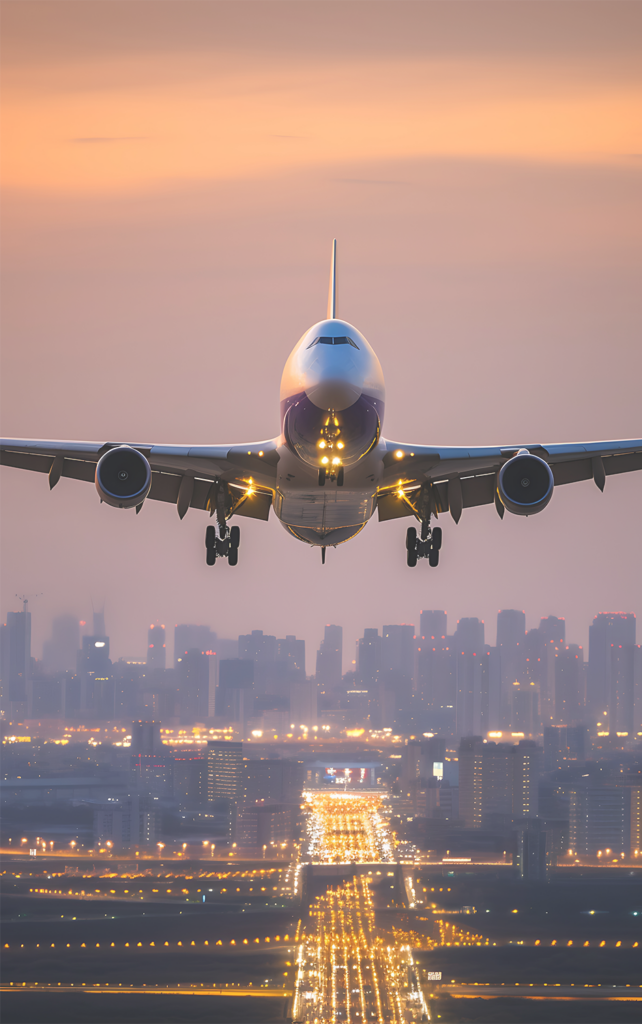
[377,440,642,522]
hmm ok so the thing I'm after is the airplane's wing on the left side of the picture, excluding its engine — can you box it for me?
[0,438,279,519]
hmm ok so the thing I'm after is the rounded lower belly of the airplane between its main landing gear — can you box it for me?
[274,485,376,545]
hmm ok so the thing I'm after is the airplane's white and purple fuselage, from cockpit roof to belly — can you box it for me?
[273,319,385,547]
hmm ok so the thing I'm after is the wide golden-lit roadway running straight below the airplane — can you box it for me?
[293,794,430,1024]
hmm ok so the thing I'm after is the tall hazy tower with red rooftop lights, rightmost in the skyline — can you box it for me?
[587,611,636,732]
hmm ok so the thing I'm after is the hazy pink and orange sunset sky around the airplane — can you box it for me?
[0,0,642,671]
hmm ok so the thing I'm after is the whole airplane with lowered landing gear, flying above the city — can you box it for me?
[0,239,642,566]
